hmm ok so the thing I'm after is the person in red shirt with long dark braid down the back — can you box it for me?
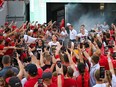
[76,63,90,87]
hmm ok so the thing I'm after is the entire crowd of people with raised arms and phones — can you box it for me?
[0,20,116,87]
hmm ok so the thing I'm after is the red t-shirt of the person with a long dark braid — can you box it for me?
[76,70,90,87]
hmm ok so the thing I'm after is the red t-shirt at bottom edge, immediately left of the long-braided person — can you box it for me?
[63,78,77,87]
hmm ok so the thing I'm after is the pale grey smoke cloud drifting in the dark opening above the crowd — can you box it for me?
[65,4,105,32]
